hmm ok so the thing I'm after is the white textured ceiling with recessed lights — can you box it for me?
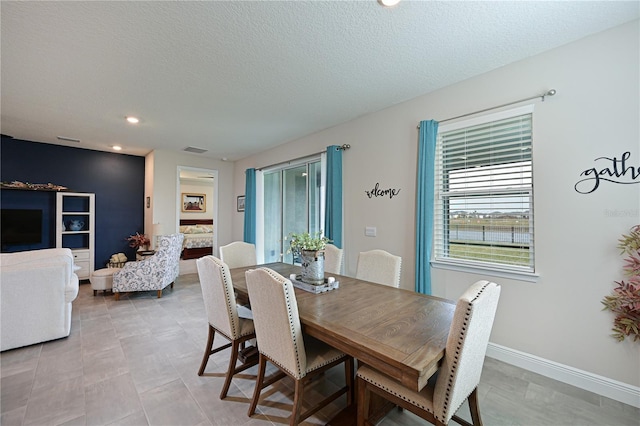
[0,0,640,160]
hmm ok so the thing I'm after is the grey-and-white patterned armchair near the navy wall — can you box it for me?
[113,234,184,300]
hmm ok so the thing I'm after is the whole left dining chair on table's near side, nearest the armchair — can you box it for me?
[196,255,258,399]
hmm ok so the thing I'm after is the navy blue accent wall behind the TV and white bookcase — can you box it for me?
[0,136,145,269]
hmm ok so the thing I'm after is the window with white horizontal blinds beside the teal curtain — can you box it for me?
[434,106,535,273]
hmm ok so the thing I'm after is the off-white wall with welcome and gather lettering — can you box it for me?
[233,21,640,386]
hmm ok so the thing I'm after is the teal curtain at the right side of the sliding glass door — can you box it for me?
[324,145,342,248]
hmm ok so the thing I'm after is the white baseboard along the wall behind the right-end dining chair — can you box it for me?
[487,343,640,408]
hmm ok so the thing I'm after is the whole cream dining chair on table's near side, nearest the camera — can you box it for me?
[246,268,354,425]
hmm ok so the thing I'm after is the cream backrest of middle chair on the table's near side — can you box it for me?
[245,268,307,379]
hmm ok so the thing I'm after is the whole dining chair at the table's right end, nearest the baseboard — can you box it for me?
[357,281,500,426]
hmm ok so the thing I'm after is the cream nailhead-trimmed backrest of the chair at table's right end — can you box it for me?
[433,281,500,424]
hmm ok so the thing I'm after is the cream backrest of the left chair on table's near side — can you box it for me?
[196,255,240,340]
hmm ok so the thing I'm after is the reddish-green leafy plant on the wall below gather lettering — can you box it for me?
[602,225,640,342]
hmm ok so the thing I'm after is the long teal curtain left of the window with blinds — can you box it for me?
[416,120,438,294]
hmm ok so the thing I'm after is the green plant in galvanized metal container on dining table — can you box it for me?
[289,231,330,285]
